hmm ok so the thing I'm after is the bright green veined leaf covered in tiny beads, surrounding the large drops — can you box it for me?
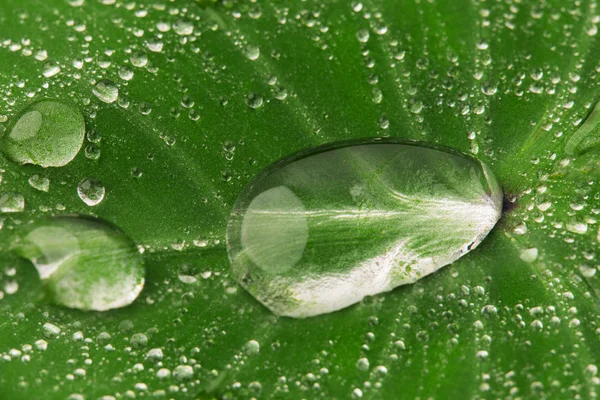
[0,0,600,399]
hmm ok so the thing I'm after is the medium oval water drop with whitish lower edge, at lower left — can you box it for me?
[11,216,145,311]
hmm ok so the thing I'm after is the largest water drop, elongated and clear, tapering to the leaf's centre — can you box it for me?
[227,139,502,318]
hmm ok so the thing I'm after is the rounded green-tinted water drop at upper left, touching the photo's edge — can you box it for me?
[0,100,85,167]
